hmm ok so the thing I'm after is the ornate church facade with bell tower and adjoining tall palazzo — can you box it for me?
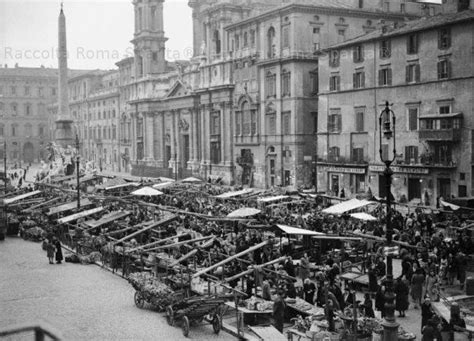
[117,0,430,187]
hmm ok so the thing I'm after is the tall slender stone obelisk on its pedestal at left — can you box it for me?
[55,3,74,148]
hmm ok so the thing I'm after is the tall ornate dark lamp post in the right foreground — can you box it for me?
[379,101,399,341]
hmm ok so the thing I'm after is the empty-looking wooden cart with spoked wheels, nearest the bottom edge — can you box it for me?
[166,296,225,337]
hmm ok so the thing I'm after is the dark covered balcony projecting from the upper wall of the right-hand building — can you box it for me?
[419,113,463,142]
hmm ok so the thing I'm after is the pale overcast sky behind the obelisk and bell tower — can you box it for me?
[0,0,192,69]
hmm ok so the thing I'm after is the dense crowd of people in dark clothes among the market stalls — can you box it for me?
[4,173,472,340]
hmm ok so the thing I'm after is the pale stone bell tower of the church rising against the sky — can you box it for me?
[131,0,168,79]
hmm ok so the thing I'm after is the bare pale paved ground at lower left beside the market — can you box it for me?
[0,238,235,341]
